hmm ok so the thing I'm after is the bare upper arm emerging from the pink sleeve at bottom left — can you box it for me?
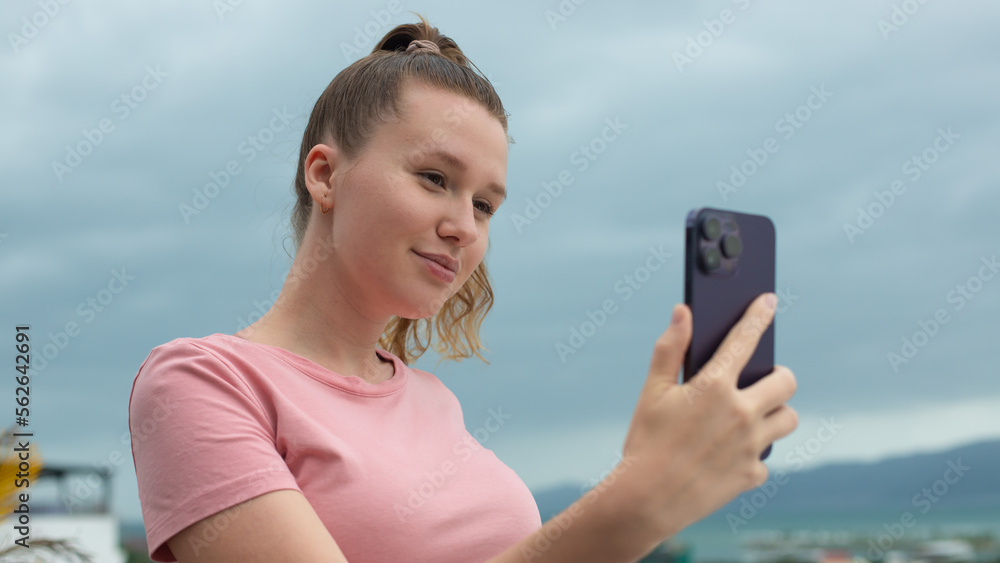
[167,489,347,563]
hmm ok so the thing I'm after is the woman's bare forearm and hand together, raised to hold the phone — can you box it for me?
[489,295,798,563]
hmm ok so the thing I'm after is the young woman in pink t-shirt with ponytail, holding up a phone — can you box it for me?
[129,13,797,563]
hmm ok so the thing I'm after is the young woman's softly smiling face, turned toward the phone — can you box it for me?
[314,82,507,319]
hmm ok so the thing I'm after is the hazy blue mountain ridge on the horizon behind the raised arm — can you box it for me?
[532,440,1000,522]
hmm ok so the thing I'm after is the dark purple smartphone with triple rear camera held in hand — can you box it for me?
[684,207,775,460]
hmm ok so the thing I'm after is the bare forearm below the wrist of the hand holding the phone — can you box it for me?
[487,456,667,563]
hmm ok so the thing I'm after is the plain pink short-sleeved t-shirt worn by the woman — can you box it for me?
[129,333,542,563]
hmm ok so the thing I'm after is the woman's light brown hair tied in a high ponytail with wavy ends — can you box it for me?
[291,12,514,364]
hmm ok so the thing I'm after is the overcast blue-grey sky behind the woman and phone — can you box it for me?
[0,0,1000,528]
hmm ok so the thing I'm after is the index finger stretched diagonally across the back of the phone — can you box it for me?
[699,293,777,386]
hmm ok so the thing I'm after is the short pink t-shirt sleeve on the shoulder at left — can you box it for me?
[129,339,301,562]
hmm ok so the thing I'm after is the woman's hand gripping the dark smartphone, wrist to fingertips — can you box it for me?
[614,294,798,545]
